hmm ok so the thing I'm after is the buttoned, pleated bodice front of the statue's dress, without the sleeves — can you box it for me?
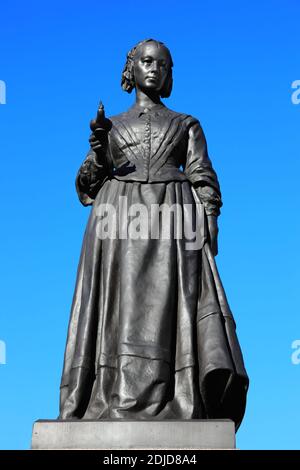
[108,105,197,183]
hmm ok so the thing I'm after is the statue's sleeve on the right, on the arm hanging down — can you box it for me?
[184,120,222,216]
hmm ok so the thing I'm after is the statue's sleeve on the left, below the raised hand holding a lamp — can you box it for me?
[76,149,108,206]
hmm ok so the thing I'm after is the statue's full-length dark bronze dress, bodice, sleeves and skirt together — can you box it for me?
[60,104,248,427]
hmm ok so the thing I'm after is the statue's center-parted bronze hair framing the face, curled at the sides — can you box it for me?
[121,39,173,98]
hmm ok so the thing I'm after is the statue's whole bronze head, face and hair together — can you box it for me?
[121,39,173,98]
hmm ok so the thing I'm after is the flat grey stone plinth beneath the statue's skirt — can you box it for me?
[31,419,235,450]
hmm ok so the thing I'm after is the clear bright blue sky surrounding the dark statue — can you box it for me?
[0,0,300,449]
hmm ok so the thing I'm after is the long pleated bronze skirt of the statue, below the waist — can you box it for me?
[60,179,248,427]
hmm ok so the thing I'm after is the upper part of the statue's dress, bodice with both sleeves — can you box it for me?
[76,104,222,215]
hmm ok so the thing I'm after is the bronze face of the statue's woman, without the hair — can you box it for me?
[134,42,171,94]
